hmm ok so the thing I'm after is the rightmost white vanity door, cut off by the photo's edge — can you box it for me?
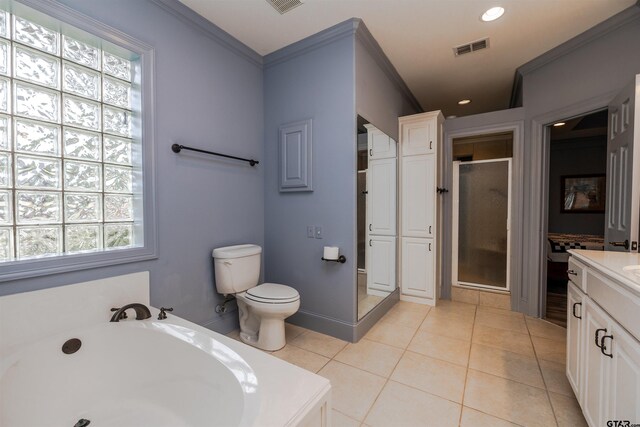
[604,322,640,423]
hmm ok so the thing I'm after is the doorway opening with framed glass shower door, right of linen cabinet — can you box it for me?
[451,132,513,299]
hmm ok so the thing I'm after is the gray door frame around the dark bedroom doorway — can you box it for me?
[520,89,619,317]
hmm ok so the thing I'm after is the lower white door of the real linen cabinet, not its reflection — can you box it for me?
[401,237,435,299]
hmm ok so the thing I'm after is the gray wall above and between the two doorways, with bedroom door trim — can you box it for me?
[446,6,640,315]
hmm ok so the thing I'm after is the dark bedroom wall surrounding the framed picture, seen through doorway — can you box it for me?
[548,136,607,235]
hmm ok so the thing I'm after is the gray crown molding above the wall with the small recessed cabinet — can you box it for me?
[263,18,360,68]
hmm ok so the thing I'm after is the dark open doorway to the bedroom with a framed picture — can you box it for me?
[543,109,607,327]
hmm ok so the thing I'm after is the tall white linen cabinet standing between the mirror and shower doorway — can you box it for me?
[399,111,444,305]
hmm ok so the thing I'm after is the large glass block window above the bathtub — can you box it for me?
[0,6,142,263]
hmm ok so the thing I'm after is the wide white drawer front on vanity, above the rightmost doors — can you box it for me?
[586,270,640,340]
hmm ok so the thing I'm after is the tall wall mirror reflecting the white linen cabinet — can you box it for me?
[356,116,398,320]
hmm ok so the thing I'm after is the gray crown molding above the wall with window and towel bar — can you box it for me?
[150,0,263,68]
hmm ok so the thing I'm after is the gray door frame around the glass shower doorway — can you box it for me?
[440,120,527,311]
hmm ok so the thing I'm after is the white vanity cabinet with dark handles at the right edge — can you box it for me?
[566,251,640,427]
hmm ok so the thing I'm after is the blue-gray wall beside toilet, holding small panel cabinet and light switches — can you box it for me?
[264,25,356,339]
